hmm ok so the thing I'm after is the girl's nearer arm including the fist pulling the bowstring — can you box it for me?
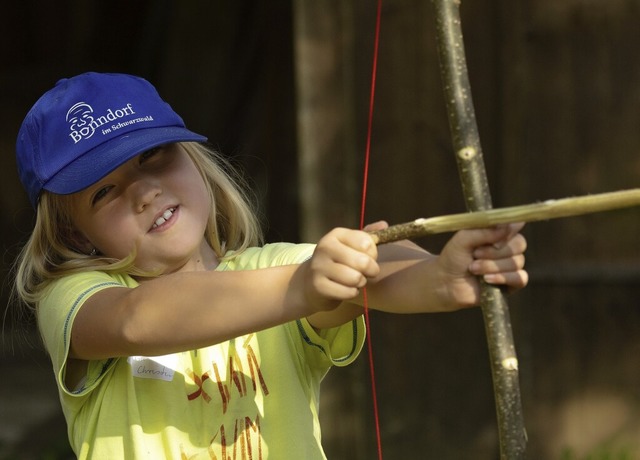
[70,238,379,360]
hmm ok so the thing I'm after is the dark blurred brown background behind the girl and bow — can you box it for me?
[0,0,640,459]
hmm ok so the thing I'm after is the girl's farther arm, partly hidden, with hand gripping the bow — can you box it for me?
[309,223,528,328]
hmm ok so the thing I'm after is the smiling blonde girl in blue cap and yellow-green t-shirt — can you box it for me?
[16,73,527,459]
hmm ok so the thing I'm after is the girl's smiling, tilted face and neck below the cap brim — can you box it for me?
[72,144,217,273]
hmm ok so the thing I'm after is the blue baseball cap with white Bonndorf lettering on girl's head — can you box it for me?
[16,72,207,207]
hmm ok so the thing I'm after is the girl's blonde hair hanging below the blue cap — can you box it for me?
[13,142,262,308]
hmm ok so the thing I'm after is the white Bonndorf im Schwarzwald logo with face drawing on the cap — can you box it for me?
[66,102,144,144]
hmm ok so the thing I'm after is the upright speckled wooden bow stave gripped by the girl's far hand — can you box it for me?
[432,0,526,460]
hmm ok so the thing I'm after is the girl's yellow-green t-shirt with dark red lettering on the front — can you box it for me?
[38,243,365,460]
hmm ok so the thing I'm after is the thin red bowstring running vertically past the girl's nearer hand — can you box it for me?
[360,0,382,460]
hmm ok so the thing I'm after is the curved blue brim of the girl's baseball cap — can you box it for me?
[43,126,207,195]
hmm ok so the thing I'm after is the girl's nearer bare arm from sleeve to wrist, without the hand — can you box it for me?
[71,266,309,360]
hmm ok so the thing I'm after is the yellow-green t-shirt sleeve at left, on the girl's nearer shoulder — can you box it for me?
[37,271,124,394]
